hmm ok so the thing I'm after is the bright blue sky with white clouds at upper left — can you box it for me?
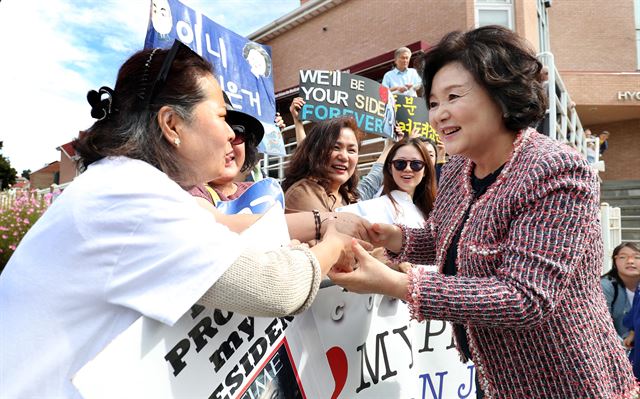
[0,0,300,175]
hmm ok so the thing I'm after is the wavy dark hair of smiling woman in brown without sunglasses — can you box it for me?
[282,117,363,203]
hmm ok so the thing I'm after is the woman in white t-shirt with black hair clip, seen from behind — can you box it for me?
[0,41,360,398]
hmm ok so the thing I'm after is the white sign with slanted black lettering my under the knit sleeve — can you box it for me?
[73,305,331,399]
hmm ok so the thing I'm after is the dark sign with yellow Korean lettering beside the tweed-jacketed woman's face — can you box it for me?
[393,94,440,143]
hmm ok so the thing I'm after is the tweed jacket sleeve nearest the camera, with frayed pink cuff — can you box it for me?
[407,152,601,327]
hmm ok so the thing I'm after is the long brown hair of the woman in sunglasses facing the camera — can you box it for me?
[382,137,436,219]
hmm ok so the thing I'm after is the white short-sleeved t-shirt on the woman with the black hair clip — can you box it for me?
[0,157,243,398]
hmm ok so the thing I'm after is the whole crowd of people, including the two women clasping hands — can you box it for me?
[0,26,640,398]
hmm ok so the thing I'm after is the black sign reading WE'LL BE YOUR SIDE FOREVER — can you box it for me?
[299,70,395,138]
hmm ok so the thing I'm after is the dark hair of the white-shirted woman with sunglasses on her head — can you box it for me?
[73,45,213,184]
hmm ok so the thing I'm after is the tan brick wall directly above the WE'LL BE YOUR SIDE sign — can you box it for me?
[264,0,473,92]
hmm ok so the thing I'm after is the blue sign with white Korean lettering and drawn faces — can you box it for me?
[144,0,286,156]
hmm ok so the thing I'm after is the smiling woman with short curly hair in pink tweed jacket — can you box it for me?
[330,26,638,399]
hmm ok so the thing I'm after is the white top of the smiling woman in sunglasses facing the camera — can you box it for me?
[336,190,424,228]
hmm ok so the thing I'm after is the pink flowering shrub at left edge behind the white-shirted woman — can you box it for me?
[0,191,53,272]
